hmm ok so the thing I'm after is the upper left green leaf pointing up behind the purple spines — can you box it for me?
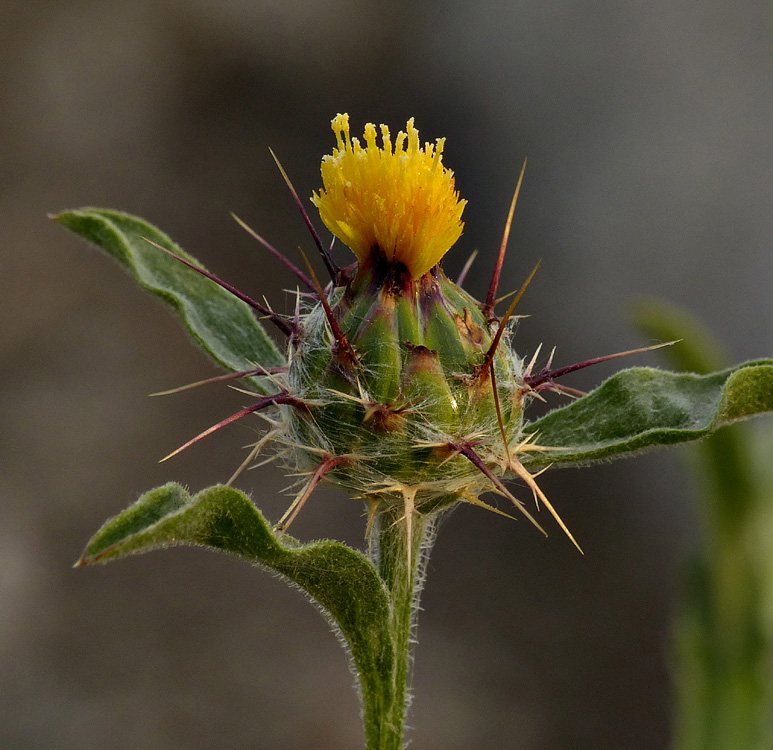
[53,208,285,393]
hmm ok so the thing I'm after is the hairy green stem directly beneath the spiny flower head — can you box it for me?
[363,508,433,750]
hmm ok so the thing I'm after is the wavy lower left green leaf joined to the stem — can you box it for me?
[77,483,395,740]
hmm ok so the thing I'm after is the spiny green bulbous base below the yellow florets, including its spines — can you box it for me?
[164,226,574,541]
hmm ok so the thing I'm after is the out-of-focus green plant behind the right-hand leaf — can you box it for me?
[636,301,773,750]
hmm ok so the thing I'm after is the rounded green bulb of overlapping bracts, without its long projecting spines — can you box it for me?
[279,268,528,512]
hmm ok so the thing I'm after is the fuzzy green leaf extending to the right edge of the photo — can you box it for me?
[526,360,773,466]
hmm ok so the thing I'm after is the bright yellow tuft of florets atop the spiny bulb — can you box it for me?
[311,114,467,278]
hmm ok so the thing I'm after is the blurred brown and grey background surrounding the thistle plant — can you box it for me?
[0,0,773,750]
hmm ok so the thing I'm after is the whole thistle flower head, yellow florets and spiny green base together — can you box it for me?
[128,115,589,552]
